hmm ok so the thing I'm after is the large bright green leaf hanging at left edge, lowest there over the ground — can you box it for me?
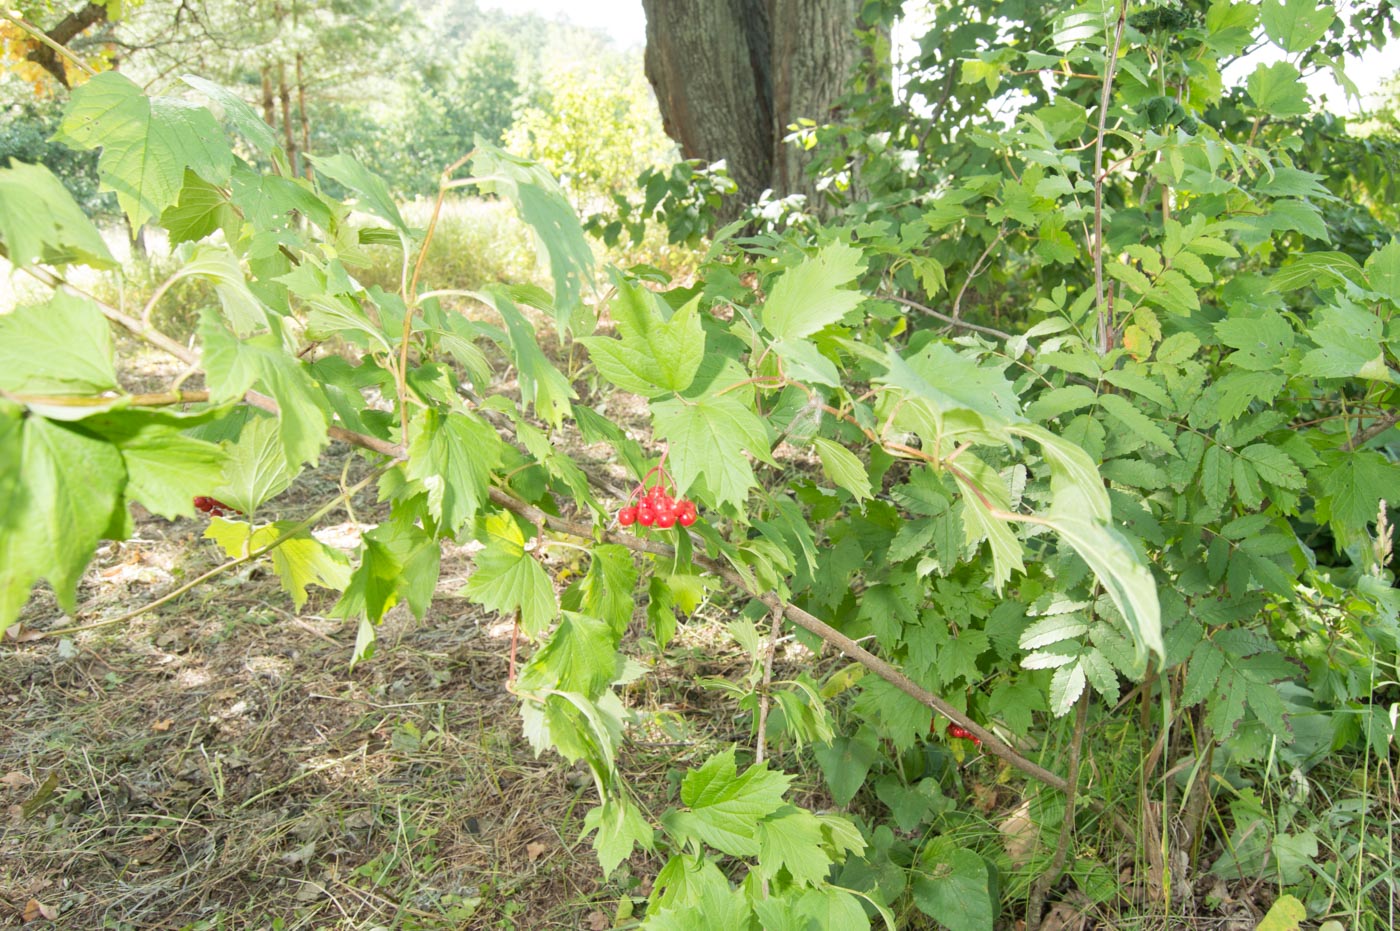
[0,412,126,631]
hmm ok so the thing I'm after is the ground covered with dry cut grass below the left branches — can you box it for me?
[0,431,756,931]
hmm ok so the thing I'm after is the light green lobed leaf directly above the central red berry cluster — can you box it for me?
[651,395,770,507]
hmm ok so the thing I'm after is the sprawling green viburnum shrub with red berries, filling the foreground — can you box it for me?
[0,4,1400,931]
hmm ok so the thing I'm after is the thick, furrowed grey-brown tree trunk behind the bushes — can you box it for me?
[643,0,860,208]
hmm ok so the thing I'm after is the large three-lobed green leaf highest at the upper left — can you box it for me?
[53,71,234,228]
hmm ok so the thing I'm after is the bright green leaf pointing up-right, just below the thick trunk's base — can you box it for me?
[762,241,865,340]
